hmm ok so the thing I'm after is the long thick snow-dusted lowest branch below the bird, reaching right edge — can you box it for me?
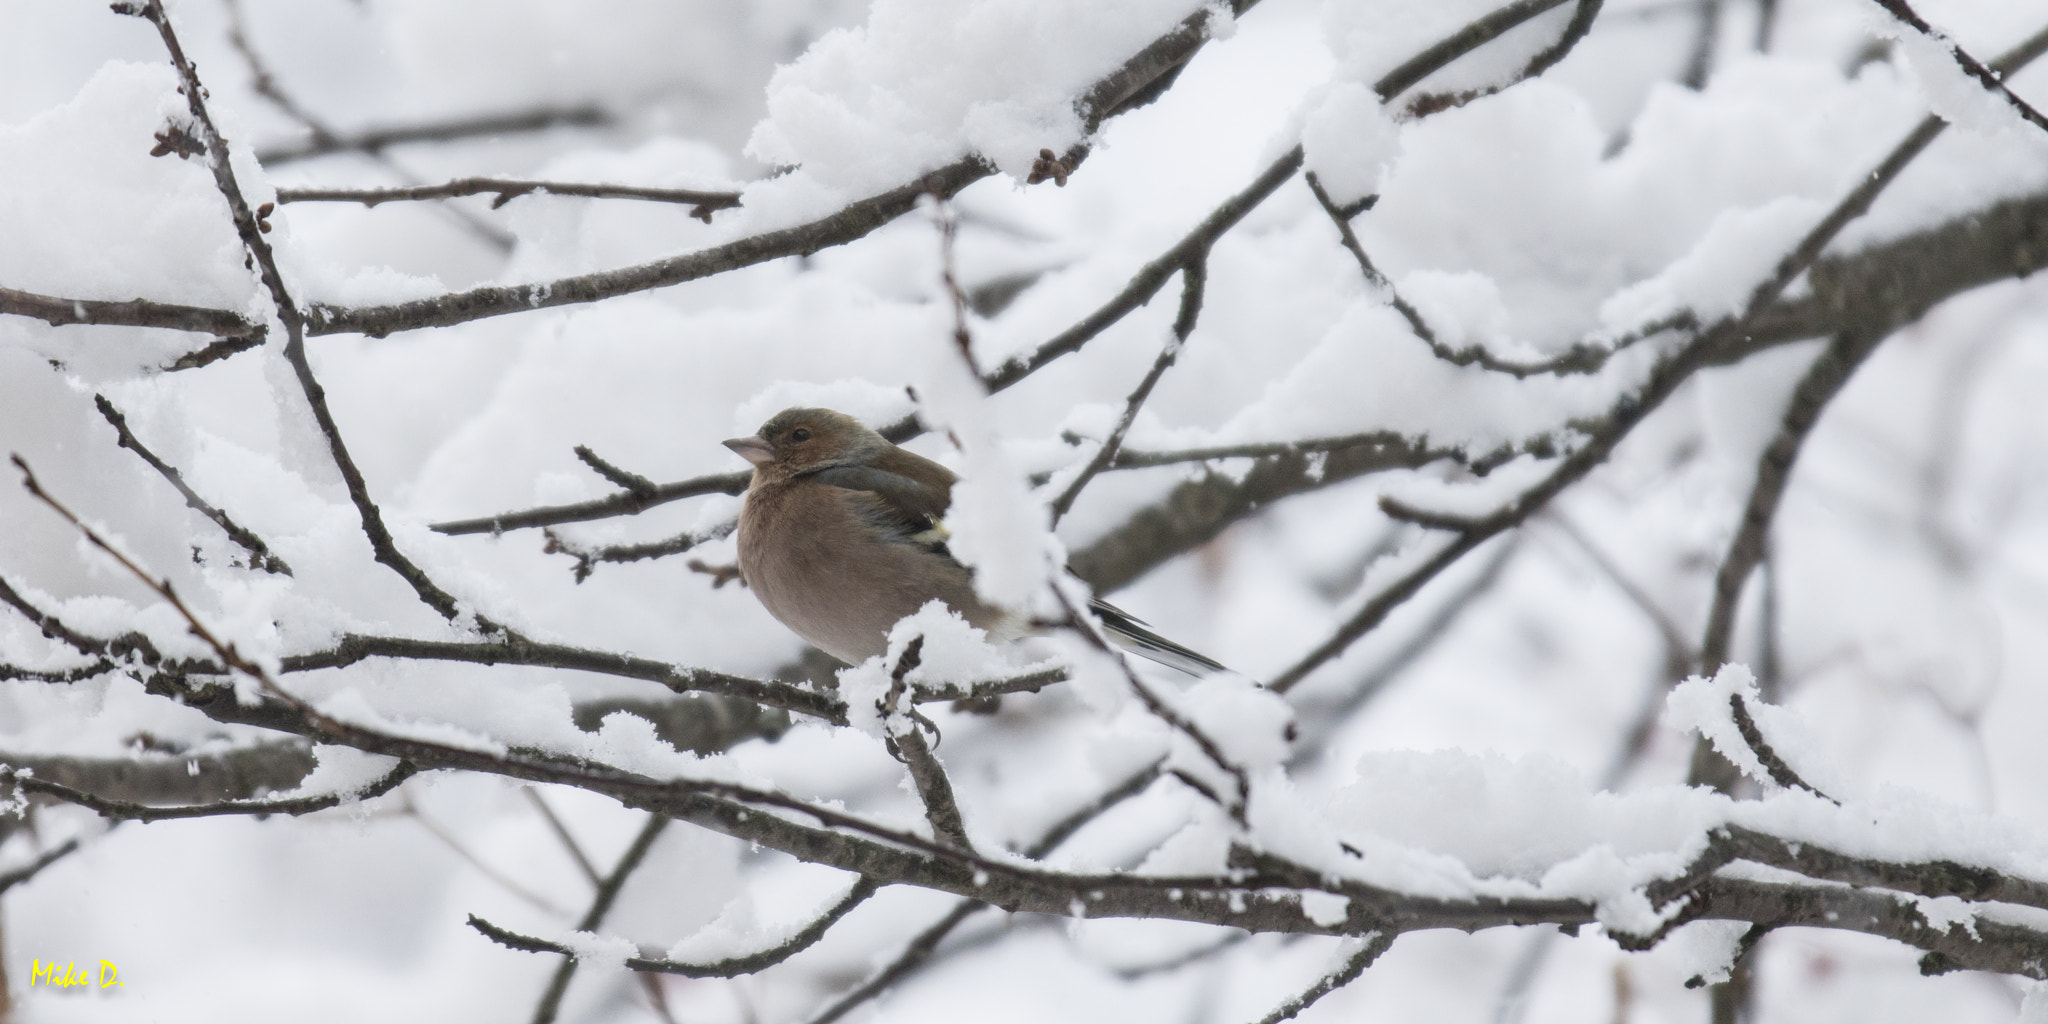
[68,622,2048,977]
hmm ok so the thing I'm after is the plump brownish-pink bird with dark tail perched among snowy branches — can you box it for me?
[725,408,1229,676]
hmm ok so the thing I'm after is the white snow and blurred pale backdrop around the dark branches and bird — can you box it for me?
[0,0,2048,1024]
